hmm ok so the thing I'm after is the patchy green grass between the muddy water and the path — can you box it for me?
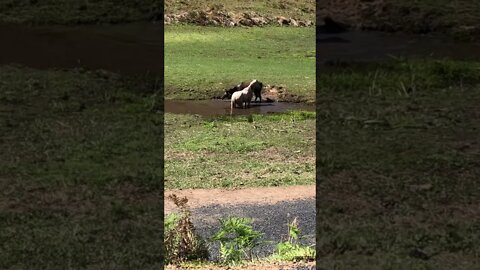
[165,112,315,189]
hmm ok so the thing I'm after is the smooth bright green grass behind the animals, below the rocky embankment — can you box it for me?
[165,26,315,100]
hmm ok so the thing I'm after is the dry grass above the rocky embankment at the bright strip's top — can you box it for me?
[165,0,315,21]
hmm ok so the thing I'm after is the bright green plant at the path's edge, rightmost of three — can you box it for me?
[272,218,315,261]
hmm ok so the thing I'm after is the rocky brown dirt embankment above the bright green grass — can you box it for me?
[164,9,314,27]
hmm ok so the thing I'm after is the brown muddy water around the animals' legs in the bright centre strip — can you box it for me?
[165,100,315,116]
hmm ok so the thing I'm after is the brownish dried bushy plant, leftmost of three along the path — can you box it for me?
[164,194,209,263]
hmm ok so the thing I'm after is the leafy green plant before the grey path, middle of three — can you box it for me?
[212,217,263,264]
